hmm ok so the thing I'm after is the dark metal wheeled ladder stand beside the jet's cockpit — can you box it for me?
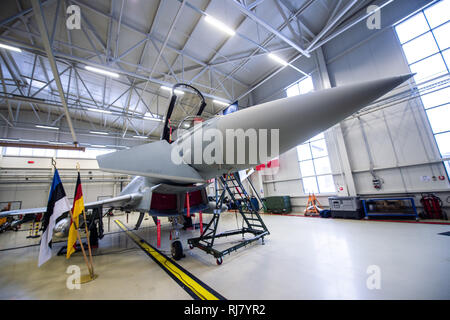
[188,172,270,265]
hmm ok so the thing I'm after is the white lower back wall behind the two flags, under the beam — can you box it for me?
[0,152,130,210]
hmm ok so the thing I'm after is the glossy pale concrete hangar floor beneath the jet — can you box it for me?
[0,213,450,299]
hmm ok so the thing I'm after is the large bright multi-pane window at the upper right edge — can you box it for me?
[395,0,450,174]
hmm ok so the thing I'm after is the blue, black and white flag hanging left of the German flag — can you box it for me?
[38,169,70,267]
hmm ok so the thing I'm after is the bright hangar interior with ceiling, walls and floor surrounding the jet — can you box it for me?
[0,0,450,299]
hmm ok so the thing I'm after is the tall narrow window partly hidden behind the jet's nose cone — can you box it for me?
[286,77,336,193]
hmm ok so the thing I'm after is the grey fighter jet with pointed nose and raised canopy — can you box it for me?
[0,75,412,257]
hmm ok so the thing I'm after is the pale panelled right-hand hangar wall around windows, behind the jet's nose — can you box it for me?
[252,0,450,212]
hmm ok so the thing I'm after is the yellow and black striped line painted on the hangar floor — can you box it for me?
[114,220,226,300]
